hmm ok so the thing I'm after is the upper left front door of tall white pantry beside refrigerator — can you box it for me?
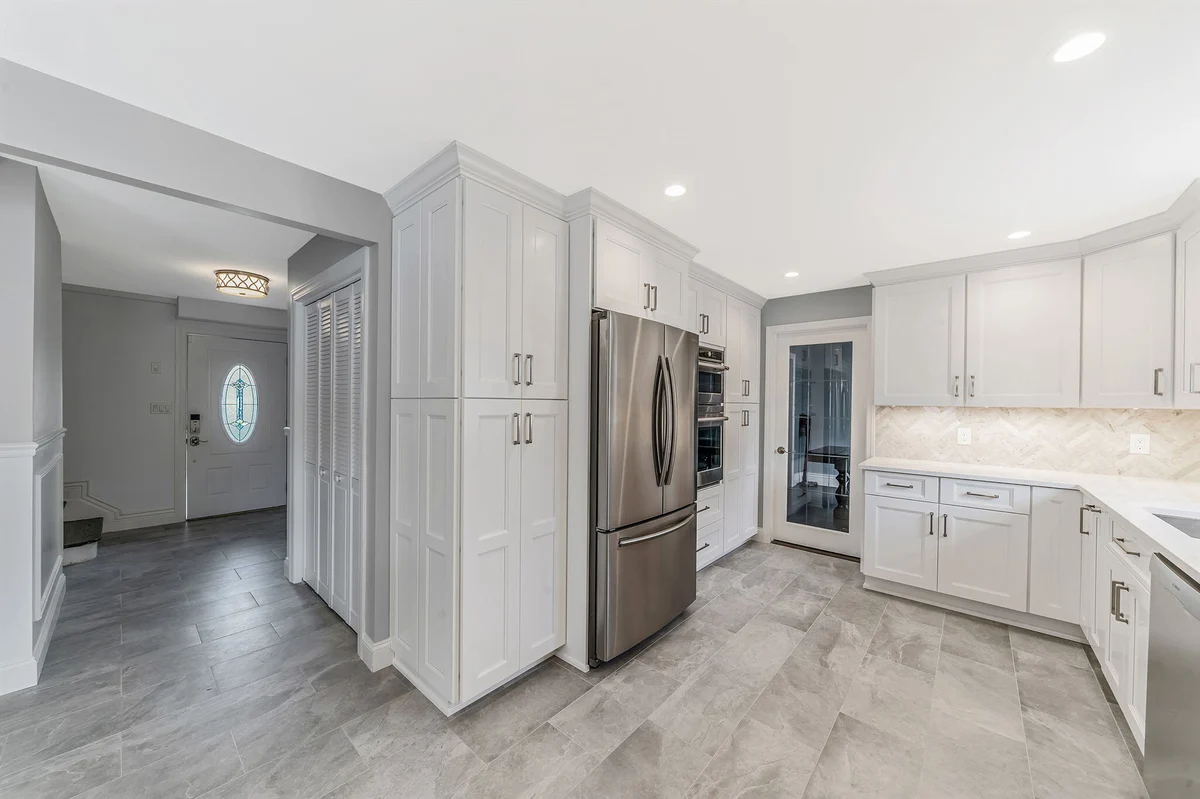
[462,180,523,398]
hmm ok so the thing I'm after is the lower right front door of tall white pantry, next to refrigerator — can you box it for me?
[520,401,568,668]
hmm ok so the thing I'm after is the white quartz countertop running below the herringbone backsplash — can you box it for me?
[862,458,1200,582]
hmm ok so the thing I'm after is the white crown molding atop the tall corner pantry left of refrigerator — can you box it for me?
[384,142,565,220]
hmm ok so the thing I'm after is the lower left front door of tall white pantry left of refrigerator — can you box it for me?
[462,400,522,698]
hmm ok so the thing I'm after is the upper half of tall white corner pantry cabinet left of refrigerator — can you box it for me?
[392,178,569,400]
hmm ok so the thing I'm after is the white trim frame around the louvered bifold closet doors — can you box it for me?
[283,246,364,635]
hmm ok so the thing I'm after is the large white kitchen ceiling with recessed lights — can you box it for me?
[0,0,1200,296]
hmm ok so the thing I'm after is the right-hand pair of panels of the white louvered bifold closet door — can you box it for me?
[329,286,354,620]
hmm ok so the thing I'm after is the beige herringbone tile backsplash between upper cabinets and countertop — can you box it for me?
[875,405,1200,481]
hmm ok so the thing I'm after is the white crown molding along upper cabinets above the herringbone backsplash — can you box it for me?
[865,179,1200,286]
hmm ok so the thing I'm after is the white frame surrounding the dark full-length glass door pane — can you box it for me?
[761,317,875,557]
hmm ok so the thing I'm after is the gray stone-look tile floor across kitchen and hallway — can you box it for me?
[0,512,1146,799]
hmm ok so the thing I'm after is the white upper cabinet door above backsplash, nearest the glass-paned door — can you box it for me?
[874,275,966,405]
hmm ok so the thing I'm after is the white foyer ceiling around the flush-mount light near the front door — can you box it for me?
[38,167,312,308]
